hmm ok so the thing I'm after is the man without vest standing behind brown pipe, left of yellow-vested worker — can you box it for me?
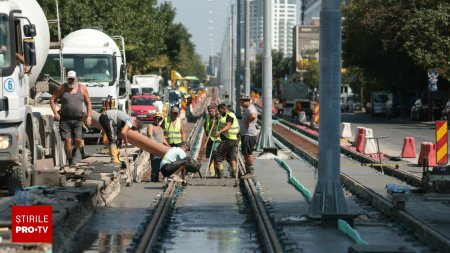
[147,112,169,182]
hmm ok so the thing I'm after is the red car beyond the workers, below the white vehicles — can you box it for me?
[131,95,158,121]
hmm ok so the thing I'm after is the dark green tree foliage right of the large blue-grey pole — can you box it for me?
[343,0,450,95]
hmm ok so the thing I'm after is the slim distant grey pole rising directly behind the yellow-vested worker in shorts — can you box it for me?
[233,0,242,119]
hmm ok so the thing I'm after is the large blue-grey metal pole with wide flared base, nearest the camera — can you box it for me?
[309,0,347,218]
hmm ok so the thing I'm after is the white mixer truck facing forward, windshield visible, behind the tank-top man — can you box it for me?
[45,29,131,112]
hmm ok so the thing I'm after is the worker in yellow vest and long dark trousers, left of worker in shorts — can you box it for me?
[203,105,220,176]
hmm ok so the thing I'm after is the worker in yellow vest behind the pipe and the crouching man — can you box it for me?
[162,106,186,147]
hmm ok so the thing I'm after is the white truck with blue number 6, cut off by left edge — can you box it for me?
[0,0,65,193]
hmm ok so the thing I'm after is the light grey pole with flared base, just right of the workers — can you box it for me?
[258,0,275,149]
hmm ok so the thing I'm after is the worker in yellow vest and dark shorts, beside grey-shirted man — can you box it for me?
[214,104,239,178]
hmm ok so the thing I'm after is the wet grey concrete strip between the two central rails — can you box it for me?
[158,185,261,252]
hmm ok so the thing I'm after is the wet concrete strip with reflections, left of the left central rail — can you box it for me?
[70,183,163,253]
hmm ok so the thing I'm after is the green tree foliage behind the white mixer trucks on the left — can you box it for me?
[38,0,204,78]
